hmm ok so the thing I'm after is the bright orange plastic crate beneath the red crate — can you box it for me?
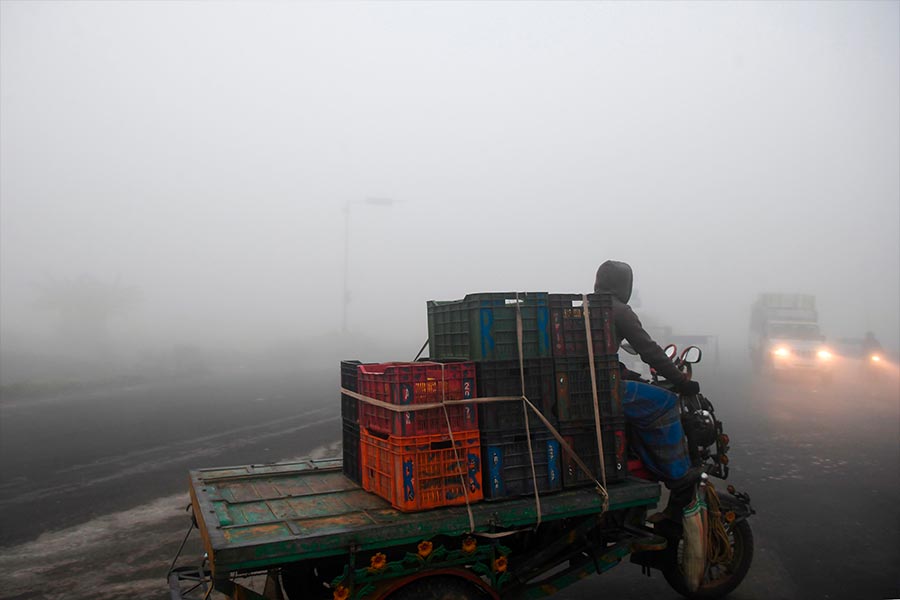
[360,430,484,512]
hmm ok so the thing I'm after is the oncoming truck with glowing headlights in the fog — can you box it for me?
[749,294,834,377]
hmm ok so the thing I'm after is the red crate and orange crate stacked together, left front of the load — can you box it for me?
[357,362,483,511]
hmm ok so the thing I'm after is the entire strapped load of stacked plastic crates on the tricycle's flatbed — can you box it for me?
[341,292,627,511]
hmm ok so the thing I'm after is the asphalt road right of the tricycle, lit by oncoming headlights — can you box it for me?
[559,363,900,600]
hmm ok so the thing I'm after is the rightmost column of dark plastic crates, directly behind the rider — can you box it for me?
[549,294,628,488]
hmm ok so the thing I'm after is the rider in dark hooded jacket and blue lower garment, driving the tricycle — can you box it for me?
[594,260,700,501]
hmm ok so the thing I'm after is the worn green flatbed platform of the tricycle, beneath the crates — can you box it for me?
[190,458,659,575]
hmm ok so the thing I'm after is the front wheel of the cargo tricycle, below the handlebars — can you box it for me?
[663,521,753,600]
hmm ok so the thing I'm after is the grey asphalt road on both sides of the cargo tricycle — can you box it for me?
[0,364,900,600]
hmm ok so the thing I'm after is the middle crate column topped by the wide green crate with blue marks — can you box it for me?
[428,292,563,500]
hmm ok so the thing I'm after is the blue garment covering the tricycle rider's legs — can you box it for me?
[622,381,691,482]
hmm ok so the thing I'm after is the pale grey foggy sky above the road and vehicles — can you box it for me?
[0,1,900,368]
